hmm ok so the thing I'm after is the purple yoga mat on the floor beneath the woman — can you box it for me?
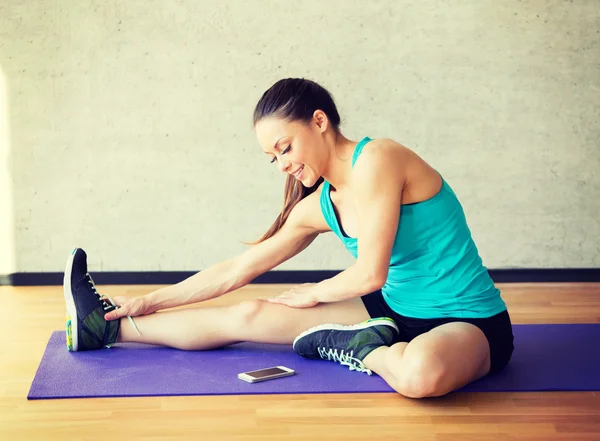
[27,324,600,399]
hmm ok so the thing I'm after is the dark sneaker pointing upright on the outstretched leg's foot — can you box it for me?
[63,248,121,352]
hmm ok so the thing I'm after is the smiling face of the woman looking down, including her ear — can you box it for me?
[254,111,327,187]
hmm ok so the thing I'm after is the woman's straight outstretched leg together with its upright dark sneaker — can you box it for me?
[64,244,369,351]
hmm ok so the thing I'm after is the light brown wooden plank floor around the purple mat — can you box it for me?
[0,284,600,441]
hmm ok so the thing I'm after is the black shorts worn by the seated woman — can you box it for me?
[362,291,514,374]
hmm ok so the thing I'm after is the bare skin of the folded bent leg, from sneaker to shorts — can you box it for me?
[364,322,490,398]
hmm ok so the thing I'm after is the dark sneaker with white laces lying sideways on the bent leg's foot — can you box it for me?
[293,317,400,375]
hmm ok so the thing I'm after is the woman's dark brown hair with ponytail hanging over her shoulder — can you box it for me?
[253,78,340,243]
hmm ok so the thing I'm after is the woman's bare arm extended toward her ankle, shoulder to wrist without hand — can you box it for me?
[147,187,329,312]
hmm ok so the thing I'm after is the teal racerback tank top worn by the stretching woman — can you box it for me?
[320,137,506,318]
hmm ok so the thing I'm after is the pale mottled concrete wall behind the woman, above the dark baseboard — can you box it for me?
[0,0,600,272]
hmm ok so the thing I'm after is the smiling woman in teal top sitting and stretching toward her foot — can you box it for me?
[65,79,513,398]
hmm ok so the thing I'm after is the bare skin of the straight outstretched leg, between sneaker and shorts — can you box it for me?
[118,298,370,350]
